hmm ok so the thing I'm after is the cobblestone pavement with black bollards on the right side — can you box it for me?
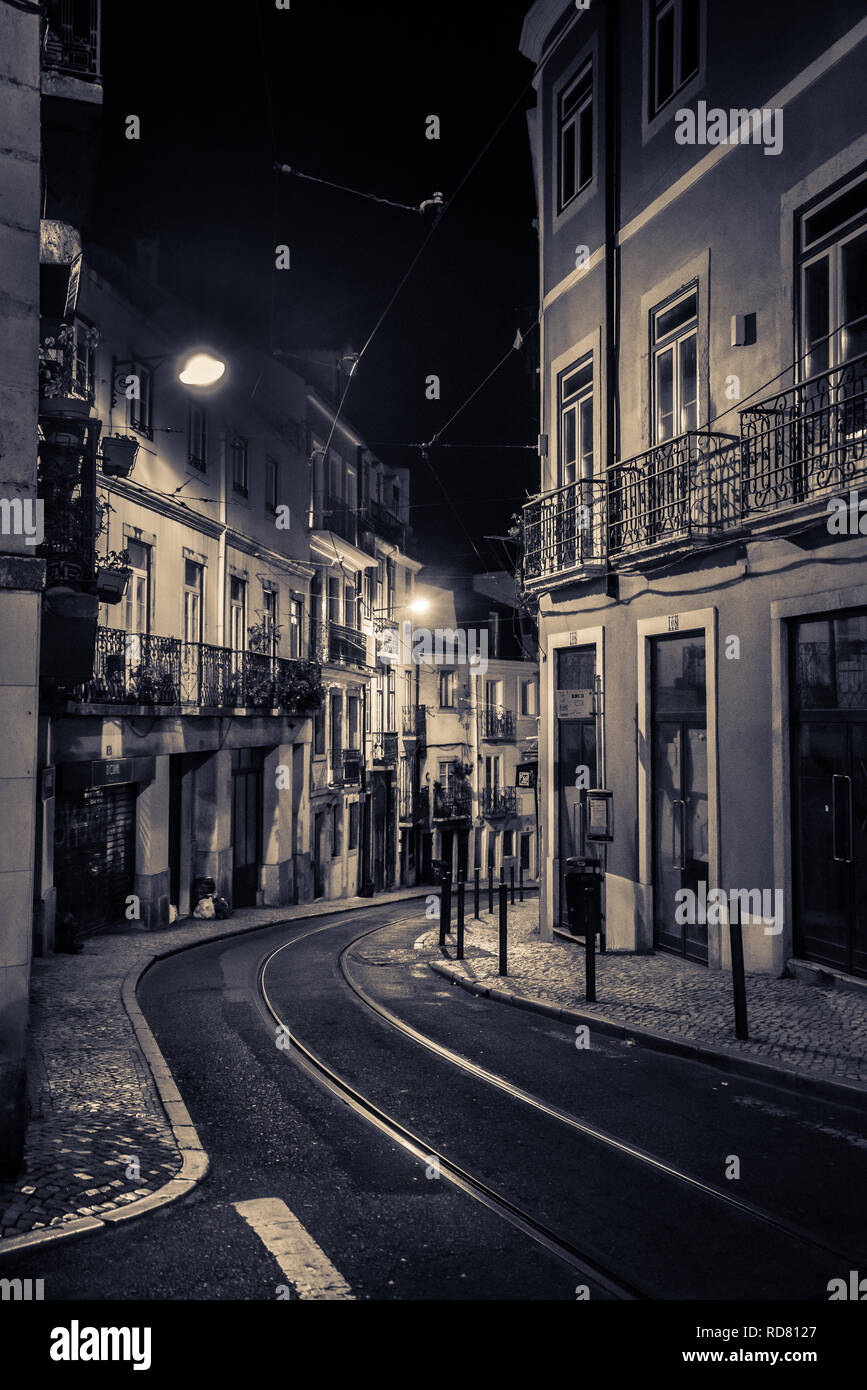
[408,901,867,1083]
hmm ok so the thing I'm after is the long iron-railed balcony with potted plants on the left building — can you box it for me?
[63,627,322,714]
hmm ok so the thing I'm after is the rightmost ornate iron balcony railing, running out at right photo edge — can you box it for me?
[741,354,867,517]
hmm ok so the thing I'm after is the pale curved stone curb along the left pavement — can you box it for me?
[0,892,424,1258]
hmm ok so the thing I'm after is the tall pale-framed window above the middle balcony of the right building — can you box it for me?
[650,289,699,443]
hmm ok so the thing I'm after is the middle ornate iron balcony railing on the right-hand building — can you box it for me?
[609,430,741,556]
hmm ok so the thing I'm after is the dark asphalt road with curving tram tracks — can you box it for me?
[3,904,867,1301]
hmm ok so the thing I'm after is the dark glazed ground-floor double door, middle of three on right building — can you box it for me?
[652,634,709,965]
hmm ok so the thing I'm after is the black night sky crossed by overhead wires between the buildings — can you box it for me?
[90,0,539,571]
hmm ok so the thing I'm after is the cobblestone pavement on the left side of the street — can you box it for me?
[0,890,420,1250]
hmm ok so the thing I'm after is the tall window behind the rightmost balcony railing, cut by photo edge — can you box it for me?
[799,178,867,378]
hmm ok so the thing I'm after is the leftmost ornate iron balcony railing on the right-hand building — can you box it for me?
[524,478,607,581]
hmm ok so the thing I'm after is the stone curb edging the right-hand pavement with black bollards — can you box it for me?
[428,960,867,1109]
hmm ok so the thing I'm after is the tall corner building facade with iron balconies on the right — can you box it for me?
[521,0,867,977]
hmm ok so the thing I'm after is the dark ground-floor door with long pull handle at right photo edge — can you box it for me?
[791,610,867,977]
